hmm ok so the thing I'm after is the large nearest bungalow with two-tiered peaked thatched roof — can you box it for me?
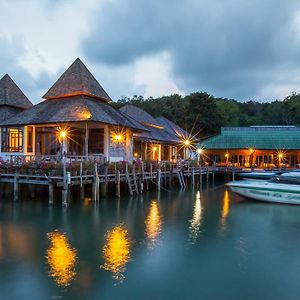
[0,59,146,161]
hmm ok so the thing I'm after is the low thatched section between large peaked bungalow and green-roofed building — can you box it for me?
[119,104,189,161]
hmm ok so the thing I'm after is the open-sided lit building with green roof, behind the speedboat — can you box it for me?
[200,126,300,168]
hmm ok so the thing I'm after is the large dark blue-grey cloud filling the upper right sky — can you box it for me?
[83,0,300,100]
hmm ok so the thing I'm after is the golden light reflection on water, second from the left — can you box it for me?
[100,224,131,282]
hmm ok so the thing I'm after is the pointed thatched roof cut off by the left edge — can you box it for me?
[0,74,32,109]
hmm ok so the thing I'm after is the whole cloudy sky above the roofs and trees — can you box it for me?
[0,0,300,103]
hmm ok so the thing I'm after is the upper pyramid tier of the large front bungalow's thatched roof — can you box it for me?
[43,58,111,102]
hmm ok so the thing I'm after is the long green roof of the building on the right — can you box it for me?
[200,126,300,150]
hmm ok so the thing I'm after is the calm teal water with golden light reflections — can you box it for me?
[0,185,300,300]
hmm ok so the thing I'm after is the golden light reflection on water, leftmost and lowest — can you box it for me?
[46,231,77,287]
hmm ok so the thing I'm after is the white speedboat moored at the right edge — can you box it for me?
[227,172,300,204]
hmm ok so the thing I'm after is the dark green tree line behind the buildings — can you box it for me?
[111,92,300,138]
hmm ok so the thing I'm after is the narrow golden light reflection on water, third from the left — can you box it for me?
[145,200,162,247]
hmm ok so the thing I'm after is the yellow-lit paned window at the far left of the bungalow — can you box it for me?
[1,128,23,152]
